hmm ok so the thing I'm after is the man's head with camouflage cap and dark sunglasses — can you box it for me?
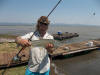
[36,16,50,33]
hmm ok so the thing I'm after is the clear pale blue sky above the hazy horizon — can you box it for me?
[0,0,100,25]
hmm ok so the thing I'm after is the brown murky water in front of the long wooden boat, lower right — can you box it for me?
[54,51,100,75]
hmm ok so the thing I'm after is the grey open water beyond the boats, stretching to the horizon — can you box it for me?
[0,26,100,42]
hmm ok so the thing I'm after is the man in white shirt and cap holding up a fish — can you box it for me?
[16,16,53,75]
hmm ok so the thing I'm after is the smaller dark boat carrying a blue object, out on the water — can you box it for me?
[53,32,79,41]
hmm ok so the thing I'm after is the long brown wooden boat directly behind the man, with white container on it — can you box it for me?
[0,40,100,69]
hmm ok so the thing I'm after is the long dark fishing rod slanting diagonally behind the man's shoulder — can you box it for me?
[2,0,62,75]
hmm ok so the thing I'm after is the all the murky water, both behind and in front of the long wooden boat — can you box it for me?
[0,26,100,75]
